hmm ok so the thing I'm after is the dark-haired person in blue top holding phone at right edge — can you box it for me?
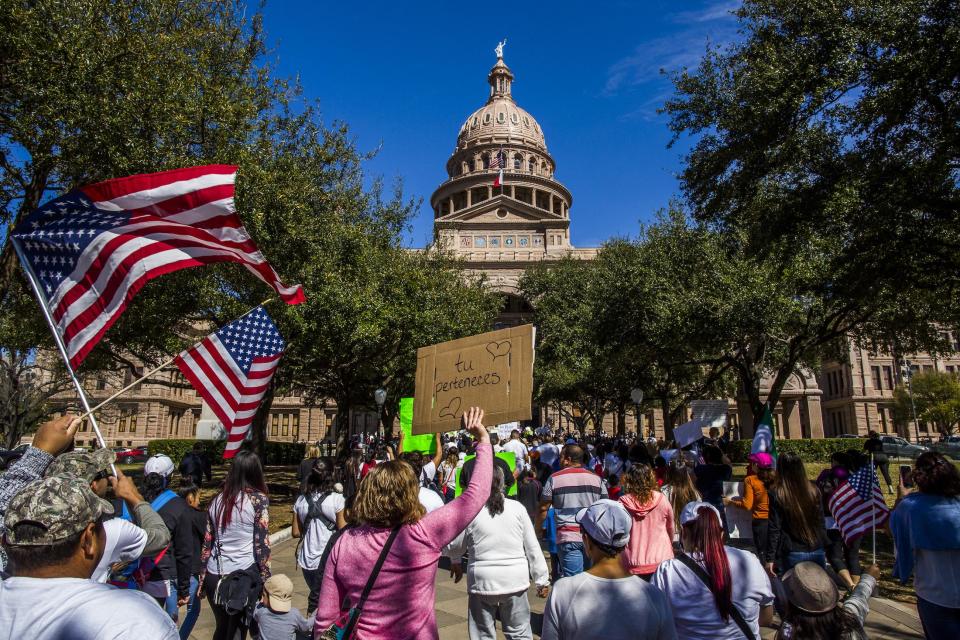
[890,451,960,640]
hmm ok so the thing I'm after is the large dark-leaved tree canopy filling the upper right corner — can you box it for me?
[665,0,960,356]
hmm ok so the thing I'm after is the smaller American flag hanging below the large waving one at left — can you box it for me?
[174,307,285,458]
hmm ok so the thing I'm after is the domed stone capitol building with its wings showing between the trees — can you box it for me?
[50,47,960,446]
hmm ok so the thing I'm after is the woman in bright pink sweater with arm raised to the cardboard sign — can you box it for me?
[314,408,493,640]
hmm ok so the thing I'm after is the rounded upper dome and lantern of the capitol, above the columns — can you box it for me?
[457,59,547,153]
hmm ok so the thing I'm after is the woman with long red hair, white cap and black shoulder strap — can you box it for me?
[651,501,773,640]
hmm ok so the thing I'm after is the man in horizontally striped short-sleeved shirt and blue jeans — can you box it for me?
[536,444,607,577]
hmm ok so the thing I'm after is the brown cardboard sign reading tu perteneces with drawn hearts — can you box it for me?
[413,324,534,434]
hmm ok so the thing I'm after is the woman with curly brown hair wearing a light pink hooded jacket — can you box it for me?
[620,464,674,580]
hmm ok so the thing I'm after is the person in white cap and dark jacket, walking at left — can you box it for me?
[140,453,200,622]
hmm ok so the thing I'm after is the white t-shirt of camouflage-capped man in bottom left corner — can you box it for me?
[0,576,180,640]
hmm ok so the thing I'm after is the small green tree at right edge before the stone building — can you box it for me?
[893,371,960,436]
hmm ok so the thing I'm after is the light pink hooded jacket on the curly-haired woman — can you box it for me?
[620,491,673,575]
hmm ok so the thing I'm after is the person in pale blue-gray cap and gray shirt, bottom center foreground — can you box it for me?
[541,499,677,640]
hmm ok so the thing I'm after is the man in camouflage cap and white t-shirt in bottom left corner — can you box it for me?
[0,475,179,640]
